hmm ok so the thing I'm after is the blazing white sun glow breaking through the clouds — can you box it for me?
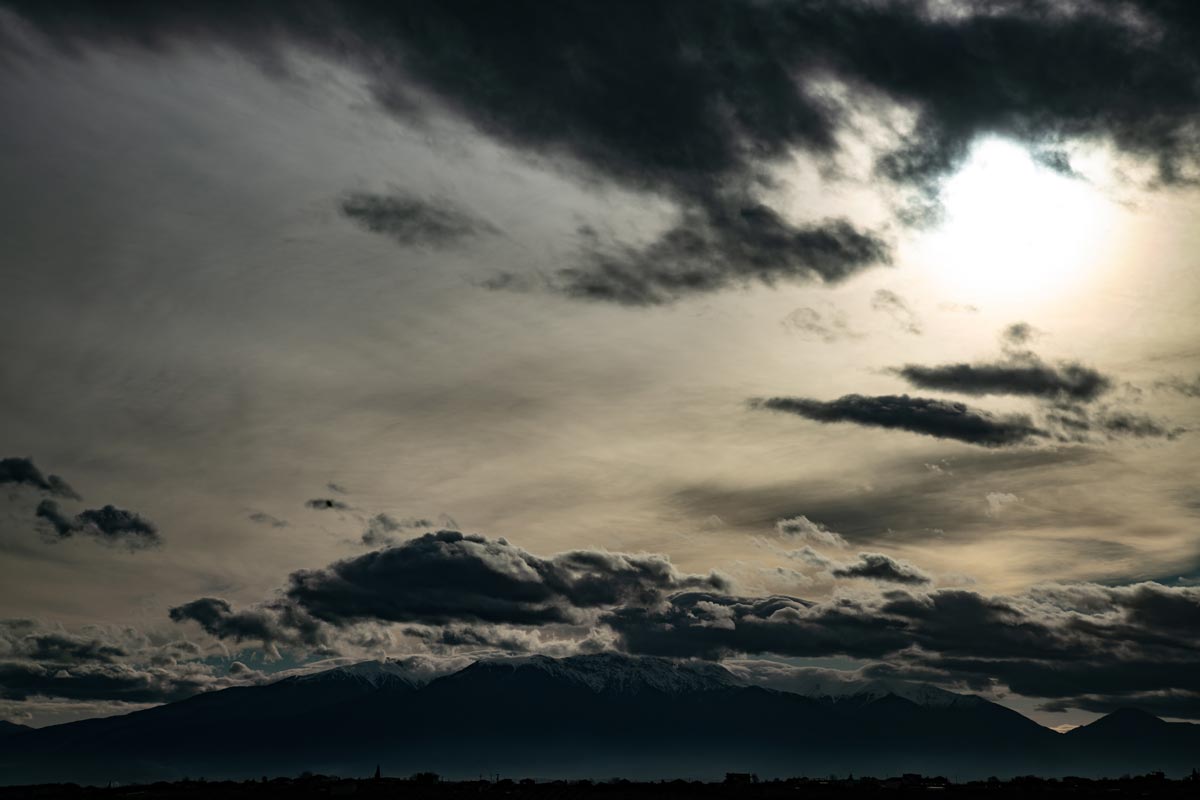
[922,139,1115,300]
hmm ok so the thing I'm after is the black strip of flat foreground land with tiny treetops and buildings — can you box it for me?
[0,772,1200,800]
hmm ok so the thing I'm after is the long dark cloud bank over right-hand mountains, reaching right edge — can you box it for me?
[602,575,1200,718]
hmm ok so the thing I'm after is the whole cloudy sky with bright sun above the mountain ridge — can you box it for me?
[0,0,1200,726]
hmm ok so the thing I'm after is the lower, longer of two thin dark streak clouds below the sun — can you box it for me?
[751,395,1049,447]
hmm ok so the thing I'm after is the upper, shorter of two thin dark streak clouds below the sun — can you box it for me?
[893,357,1112,403]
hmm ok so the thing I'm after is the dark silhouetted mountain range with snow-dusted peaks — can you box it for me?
[0,654,1200,784]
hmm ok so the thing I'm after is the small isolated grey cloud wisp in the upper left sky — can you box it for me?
[338,192,499,247]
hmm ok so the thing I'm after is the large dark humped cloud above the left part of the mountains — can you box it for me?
[170,530,728,648]
